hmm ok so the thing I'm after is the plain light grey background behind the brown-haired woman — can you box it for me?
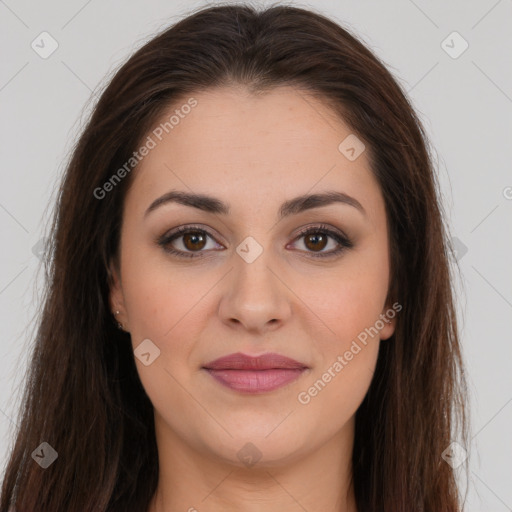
[0,0,512,512]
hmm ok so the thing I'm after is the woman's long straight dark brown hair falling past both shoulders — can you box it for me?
[0,5,467,512]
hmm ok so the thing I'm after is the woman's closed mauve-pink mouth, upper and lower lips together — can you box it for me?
[203,352,308,393]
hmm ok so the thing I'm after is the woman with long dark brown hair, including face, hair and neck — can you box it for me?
[0,5,467,512]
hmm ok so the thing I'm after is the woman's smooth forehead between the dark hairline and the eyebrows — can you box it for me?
[127,86,380,222]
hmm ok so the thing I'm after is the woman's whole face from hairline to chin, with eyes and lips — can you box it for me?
[111,87,395,465]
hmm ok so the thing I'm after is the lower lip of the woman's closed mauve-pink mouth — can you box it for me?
[206,368,306,393]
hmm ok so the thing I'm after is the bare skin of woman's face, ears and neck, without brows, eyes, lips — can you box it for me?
[111,86,395,512]
